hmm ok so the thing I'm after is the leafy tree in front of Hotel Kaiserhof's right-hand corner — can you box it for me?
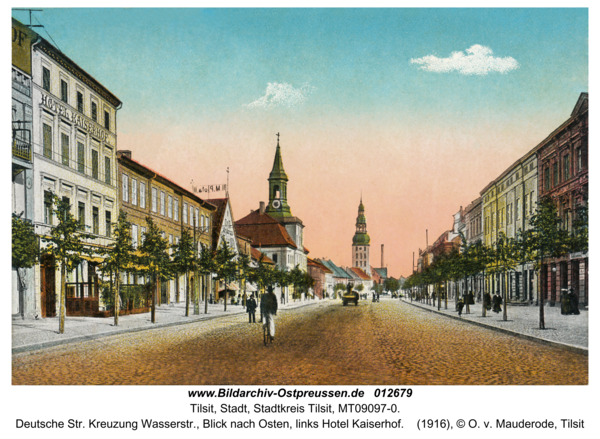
[100,210,135,326]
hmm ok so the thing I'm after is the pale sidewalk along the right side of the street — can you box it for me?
[402,299,589,355]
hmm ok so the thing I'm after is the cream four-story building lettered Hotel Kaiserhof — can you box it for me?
[31,24,122,317]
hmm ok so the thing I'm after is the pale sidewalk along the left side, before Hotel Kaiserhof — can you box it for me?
[12,299,324,354]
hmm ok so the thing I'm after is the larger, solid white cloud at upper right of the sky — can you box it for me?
[410,44,519,75]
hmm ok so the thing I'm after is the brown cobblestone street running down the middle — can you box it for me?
[12,300,588,385]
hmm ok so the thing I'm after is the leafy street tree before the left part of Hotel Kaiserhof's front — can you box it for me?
[42,195,95,334]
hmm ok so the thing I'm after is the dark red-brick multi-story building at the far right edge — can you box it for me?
[535,93,589,306]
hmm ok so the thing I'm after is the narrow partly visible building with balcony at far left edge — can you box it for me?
[11,18,37,318]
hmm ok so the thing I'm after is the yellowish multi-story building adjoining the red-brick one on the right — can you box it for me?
[480,148,538,303]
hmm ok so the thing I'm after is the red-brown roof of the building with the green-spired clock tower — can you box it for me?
[235,210,298,248]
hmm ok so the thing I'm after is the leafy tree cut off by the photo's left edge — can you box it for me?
[12,213,39,319]
